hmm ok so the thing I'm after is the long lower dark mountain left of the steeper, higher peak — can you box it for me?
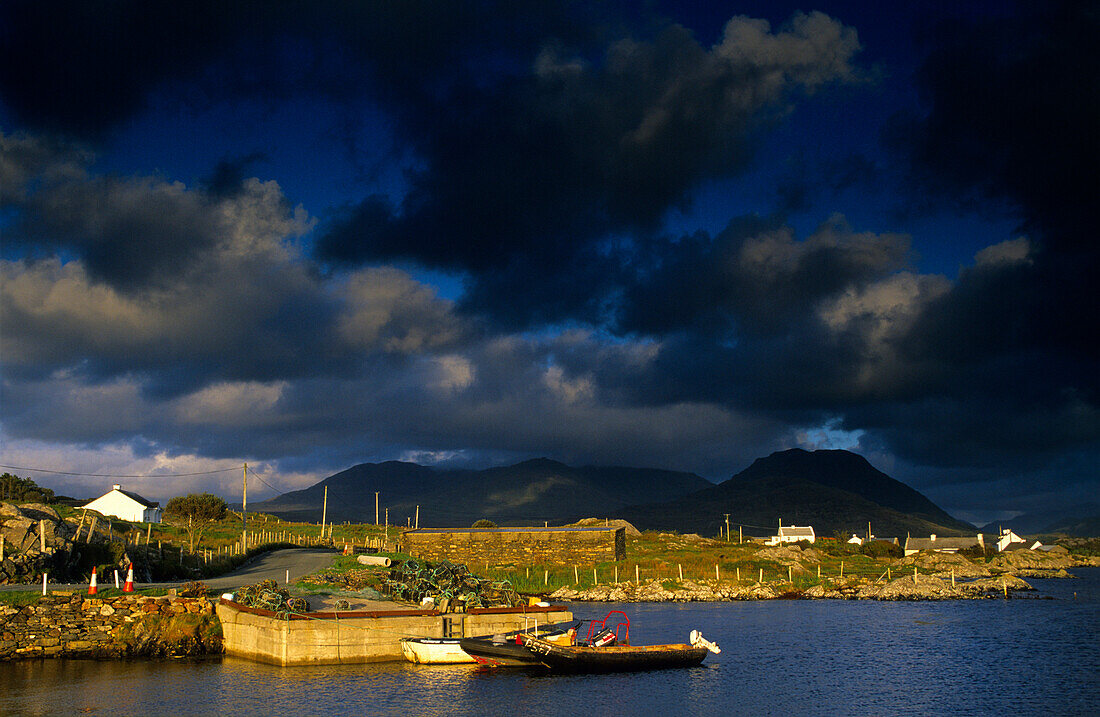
[249,459,713,528]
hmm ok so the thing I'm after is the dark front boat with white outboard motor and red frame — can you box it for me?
[518,610,722,672]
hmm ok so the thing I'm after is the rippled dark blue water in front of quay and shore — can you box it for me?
[0,569,1100,717]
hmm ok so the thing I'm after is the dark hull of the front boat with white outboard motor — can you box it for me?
[521,636,708,672]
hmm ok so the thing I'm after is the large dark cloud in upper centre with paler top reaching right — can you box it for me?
[320,13,859,324]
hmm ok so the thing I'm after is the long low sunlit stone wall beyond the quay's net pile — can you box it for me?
[400,527,626,565]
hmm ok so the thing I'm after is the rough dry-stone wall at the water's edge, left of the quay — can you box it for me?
[0,592,221,660]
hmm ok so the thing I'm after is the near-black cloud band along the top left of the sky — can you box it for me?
[0,0,572,140]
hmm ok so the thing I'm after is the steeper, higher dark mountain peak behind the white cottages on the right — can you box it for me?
[615,449,975,539]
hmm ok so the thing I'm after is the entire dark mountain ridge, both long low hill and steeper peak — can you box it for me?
[253,449,975,539]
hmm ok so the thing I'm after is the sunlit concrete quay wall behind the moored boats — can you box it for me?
[217,599,573,665]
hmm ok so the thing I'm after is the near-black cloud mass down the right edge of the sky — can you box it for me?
[871,2,1100,466]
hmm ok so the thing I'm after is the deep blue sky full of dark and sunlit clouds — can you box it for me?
[0,0,1100,523]
